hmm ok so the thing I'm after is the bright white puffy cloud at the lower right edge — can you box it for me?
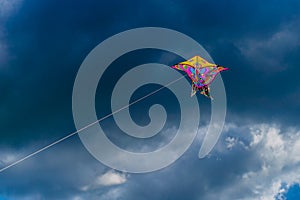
[226,124,300,200]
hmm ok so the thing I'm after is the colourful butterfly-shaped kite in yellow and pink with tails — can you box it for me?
[172,56,228,99]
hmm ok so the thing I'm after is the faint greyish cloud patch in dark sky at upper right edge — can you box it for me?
[236,21,300,72]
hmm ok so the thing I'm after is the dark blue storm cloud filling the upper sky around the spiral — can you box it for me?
[1,1,299,145]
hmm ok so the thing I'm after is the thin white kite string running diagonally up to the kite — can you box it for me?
[0,75,186,173]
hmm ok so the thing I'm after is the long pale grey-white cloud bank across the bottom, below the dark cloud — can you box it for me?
[0,123,300,200]
